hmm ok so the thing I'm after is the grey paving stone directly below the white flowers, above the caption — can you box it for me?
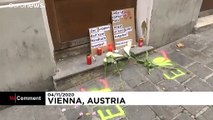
[121,65,147,88]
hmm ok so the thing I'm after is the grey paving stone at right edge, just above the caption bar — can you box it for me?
[185,77,213,91]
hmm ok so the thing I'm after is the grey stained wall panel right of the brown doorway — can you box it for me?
[149,0,202,47]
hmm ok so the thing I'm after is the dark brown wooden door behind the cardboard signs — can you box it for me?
[45,0,137,51]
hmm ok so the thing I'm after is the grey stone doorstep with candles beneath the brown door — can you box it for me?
[53,46,153,90]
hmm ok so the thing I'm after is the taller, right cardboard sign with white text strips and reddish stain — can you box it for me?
[112,8,136,50]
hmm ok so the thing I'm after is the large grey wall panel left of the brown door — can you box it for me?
[0,0,56,91]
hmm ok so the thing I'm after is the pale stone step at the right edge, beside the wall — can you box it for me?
[194,15,213,33]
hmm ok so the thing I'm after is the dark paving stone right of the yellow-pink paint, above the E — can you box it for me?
[169,52,193,66]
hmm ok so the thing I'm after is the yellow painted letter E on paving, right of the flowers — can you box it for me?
[163,69,186,80]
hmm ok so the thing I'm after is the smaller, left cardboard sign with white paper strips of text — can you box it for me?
[89,24,114,55]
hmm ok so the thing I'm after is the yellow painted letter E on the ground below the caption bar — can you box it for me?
[97,105,125,120]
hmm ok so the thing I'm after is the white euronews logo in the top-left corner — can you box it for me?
[9,0,45,8]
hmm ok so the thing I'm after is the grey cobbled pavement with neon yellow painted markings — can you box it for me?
[0,29,213,120]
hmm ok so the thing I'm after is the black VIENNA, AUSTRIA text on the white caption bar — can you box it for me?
[48,97,126,105]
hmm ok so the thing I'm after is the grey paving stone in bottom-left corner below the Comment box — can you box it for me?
[0,106,66,120]
